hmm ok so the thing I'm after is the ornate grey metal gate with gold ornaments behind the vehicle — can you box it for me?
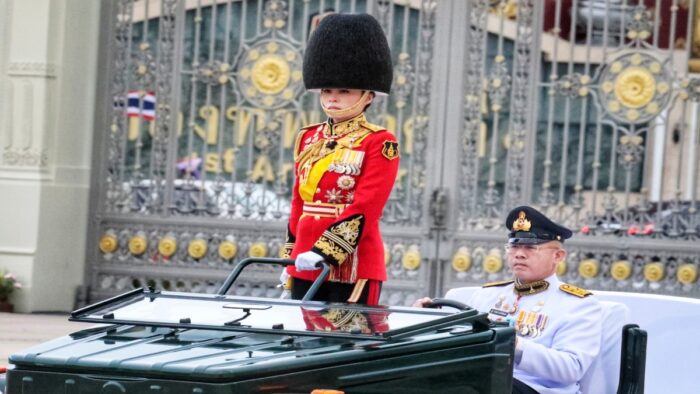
[84,0,700,304]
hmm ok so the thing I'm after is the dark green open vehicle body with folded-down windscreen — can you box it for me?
[6,259,515,394]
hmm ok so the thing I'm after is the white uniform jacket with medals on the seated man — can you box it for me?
[467,275,602,394]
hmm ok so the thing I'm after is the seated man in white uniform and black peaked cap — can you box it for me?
[414,206,602,394]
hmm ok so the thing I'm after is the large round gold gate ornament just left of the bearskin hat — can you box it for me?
[236,39,303,109]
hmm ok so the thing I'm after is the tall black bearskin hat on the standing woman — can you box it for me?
[304,14,393,94]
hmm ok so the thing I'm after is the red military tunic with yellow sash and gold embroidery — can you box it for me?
[285,114,399,283]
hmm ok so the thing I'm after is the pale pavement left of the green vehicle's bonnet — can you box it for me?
[0,312,95,367]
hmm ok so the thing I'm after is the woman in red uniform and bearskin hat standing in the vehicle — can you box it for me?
[285,14,399,305]
